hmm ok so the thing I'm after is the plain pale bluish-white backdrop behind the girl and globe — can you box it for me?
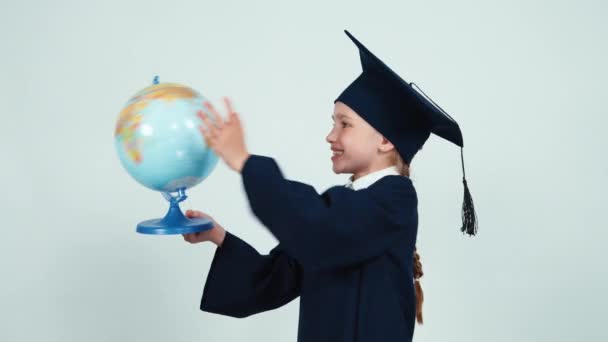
[0,0,608,342]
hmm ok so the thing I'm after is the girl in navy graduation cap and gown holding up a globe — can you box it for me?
[184,32,476,342]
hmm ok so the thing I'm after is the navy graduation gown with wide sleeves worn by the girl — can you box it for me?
[200,155,418,342]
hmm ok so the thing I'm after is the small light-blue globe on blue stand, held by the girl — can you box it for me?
[114,78,219,234]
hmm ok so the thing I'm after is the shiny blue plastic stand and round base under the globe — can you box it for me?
[137,188,213,235]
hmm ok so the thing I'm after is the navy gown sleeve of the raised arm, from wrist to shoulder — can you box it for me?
[241,155,418,270]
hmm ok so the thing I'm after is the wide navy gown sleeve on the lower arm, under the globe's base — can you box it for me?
[200,231,301,318]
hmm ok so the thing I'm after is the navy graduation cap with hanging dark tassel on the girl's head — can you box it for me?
[334,30,477,235]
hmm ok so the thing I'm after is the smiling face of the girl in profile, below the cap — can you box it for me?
[325,101,395,180]
